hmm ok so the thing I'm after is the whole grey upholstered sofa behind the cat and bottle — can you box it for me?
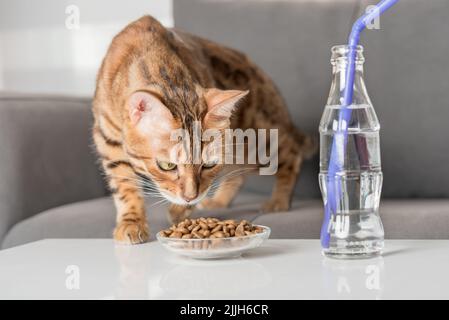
[0,0,449,248]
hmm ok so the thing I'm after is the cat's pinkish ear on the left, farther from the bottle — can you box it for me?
[128,91,174,132]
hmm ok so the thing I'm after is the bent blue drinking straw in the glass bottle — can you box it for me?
[321,0,399,248]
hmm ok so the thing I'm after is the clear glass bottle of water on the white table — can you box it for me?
[319,45,384,259]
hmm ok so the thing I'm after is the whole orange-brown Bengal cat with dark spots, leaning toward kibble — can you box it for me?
[93,16,314,244]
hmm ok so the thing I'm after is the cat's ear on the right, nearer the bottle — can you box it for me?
[204,88,249,129]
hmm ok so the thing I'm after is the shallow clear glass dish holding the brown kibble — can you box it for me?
[156,226,271,259]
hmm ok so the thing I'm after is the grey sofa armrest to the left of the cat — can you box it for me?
[0,93,106,243]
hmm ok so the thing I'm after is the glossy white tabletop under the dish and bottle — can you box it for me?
[0,239,449,299]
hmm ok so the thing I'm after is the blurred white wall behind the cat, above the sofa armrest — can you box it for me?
[0,0,173,96]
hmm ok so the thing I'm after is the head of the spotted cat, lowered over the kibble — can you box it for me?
[124,89,248,205]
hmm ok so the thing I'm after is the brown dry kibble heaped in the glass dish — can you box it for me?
[160,218,263,239]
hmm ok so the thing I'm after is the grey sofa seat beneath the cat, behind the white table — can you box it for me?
[3,192,449,248]
